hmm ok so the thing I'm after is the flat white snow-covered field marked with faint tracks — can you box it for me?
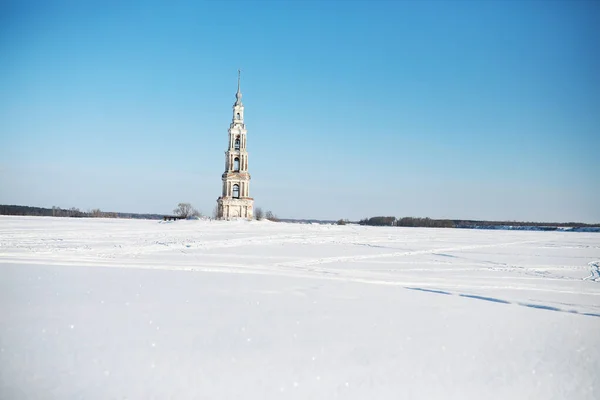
[0,217,600,399]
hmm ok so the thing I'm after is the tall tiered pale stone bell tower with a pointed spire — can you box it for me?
[217,70,254,220]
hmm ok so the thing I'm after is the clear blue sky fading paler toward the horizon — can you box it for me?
[0,0,600,222]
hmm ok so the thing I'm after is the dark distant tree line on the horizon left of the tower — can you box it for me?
[0,205,162,219]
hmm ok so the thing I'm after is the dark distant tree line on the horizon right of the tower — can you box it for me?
[356,217,600,230]
